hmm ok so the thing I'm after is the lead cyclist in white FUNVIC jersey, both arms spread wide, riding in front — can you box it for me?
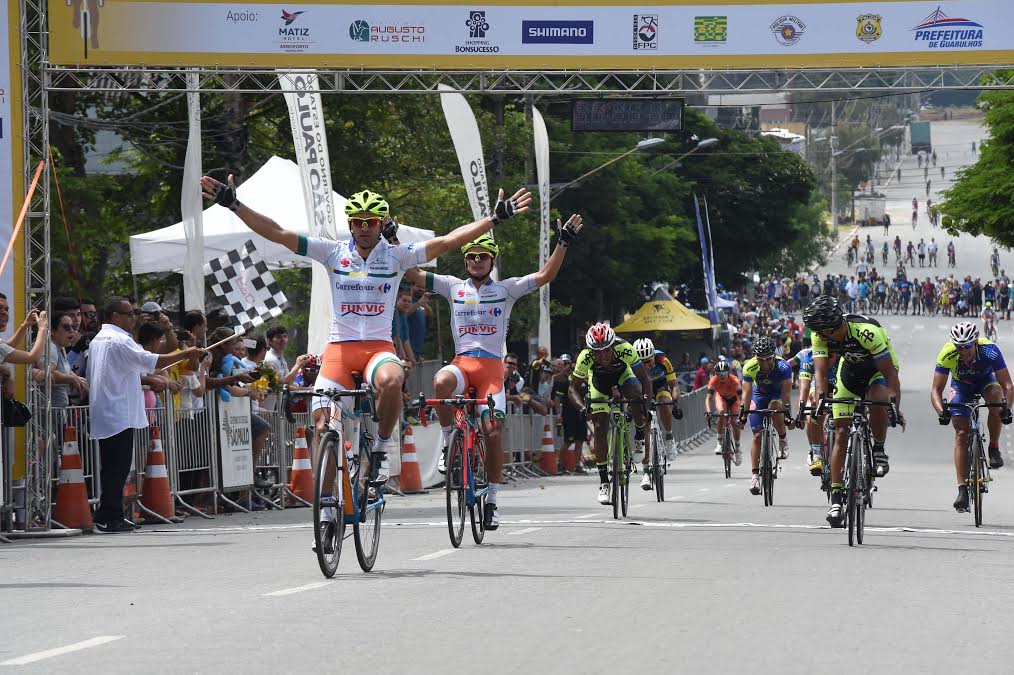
[201,175,531,488]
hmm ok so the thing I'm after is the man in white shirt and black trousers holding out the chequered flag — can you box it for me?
[87,297,205,534]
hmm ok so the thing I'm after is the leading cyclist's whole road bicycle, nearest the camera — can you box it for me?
[282,373,386,579]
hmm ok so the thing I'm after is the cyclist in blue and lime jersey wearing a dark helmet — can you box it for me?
[739,336,792,495]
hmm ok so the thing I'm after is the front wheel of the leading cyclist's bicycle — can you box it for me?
[313,432,345,579]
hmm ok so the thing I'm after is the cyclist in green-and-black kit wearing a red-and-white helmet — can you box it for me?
[568,323,653,505]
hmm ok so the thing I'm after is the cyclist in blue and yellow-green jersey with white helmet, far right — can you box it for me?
[930,321,1014,513]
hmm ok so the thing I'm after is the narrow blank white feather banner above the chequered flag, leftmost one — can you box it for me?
[179,73,204,311]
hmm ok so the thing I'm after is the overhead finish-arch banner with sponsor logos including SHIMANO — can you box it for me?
[49,0,1014,69]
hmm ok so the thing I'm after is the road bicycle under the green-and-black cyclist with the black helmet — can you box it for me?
[817,397,897,546]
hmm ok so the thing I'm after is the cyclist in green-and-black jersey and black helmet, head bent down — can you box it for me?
[803,295,904,527]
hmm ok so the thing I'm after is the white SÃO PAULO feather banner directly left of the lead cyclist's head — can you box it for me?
[278,71,338,354]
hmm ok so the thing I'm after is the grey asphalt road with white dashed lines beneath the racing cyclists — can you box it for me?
[0,117,1014,674]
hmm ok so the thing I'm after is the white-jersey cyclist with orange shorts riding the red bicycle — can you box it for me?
[406,214,583,530]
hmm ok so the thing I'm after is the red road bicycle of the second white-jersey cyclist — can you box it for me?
[419,387,498,548]
